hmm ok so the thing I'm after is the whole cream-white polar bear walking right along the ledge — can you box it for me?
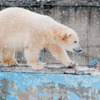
[0,7,81,69]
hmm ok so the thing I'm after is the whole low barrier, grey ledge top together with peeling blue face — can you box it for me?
[0,65,100,100]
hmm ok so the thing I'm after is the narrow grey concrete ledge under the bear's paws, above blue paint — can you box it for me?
[0,65,100,75]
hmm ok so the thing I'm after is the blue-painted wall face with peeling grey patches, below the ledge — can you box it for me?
[0,72,100,100]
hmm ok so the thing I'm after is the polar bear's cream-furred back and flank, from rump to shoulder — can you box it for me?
[0,7,56,48]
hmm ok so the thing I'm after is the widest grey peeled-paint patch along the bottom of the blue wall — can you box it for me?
[17,82,100,100]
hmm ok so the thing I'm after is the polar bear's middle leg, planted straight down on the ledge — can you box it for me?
[24,45,46,70]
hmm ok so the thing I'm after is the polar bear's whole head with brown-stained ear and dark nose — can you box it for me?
[56,27,82,52]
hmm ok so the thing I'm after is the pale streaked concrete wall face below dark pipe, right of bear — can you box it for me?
[51,4,100,64]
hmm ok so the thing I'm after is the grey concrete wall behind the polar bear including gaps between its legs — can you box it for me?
[1,0,100,65]
